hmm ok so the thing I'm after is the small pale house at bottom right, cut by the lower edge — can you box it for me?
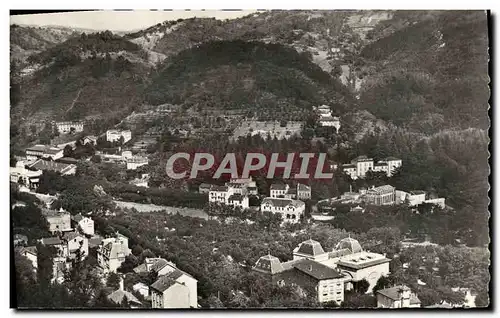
[375,285,420,308]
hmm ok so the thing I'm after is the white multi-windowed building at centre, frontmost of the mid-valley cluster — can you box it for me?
[260,198,306,223]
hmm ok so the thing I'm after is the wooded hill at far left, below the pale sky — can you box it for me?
[11,31,150,119]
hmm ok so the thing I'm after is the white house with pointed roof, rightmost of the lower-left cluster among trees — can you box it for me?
[97,232,131,273]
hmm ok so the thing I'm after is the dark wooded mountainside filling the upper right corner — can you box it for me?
[360,11,489,132]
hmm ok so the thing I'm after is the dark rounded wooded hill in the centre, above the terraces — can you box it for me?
[146,40,353,109]
